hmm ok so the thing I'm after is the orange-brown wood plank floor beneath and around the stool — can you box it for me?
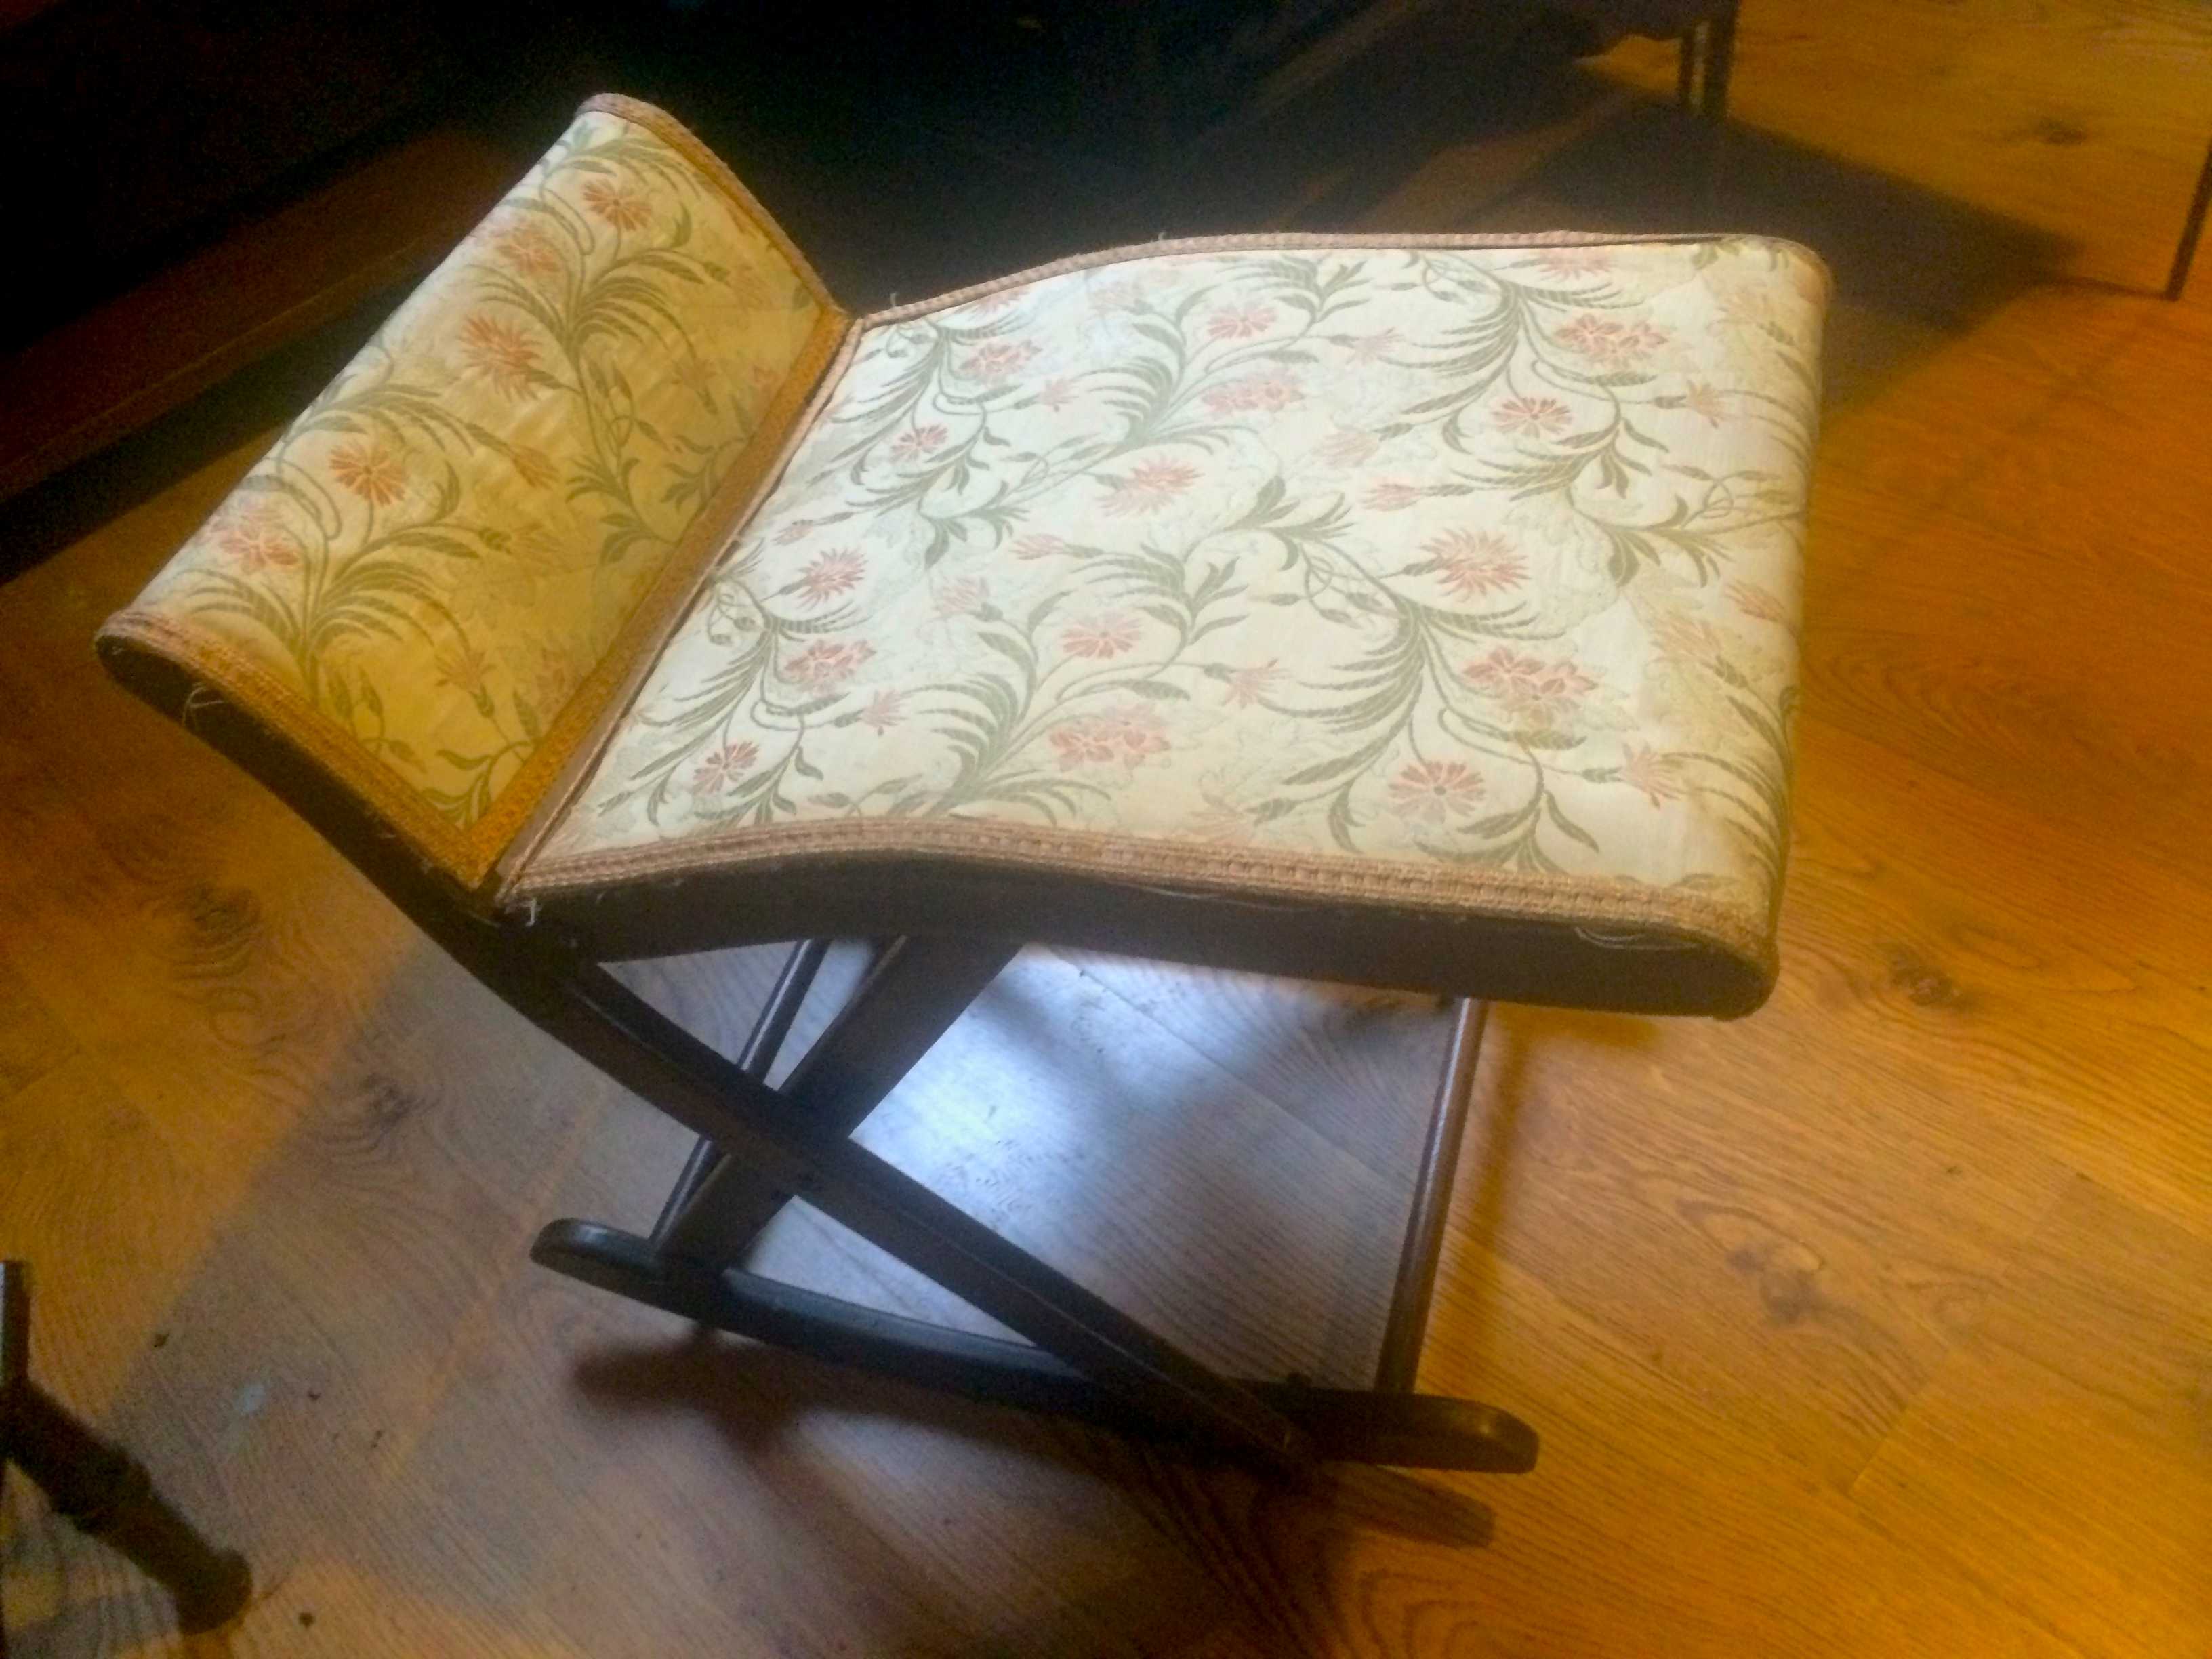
[0,0,2212,1659]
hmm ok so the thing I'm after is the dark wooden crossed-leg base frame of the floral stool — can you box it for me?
[102,639,1537,1475]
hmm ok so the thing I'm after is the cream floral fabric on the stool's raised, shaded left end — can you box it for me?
[110,100,836,876]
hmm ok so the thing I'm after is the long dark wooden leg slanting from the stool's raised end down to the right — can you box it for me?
[95,653,1530,1475]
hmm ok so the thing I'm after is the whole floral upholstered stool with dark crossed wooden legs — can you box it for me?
[102,100,1827,1469]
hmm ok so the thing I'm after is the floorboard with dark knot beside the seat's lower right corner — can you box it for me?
[1778,721,2212,1237]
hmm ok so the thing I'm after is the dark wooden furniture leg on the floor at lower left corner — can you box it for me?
[0,1261,252,1659]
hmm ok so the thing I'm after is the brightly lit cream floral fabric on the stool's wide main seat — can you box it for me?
[522,239,1827,960]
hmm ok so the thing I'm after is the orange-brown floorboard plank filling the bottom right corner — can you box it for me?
[1853,1181,2212,1659]
